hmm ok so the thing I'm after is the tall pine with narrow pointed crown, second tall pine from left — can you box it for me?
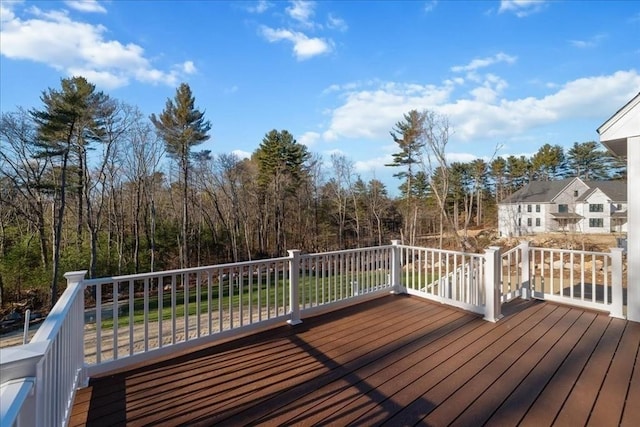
[150,83,211,268]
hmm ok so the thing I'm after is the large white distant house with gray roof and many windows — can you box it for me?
[498,178,627,237]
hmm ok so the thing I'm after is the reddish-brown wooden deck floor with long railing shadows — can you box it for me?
[70,295,640,427]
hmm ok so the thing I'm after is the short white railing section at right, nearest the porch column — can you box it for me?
[501,242,624,318]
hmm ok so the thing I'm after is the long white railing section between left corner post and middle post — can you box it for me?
[84,257,291,374]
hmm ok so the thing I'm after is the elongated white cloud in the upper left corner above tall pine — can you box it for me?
[0,4,195,88]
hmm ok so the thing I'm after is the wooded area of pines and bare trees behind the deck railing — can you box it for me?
[0,77,625,306]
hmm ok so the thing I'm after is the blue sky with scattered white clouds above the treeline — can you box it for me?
[0,0,640,192]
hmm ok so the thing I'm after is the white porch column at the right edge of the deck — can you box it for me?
[627,136,640,322]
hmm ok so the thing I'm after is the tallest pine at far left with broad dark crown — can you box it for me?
[30,77,109,306]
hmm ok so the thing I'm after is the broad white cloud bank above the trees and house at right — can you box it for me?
[308,70,640,142]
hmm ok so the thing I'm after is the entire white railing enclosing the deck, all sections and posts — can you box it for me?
[0,241,623,426]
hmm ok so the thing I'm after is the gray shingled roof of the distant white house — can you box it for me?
[501,178,627,203]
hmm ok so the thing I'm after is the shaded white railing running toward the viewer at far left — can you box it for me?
[0,271,85,426]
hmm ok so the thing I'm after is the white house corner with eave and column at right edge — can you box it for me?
[598,93,640,322]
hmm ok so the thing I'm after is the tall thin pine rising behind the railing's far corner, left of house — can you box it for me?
[386,110,426,245]
